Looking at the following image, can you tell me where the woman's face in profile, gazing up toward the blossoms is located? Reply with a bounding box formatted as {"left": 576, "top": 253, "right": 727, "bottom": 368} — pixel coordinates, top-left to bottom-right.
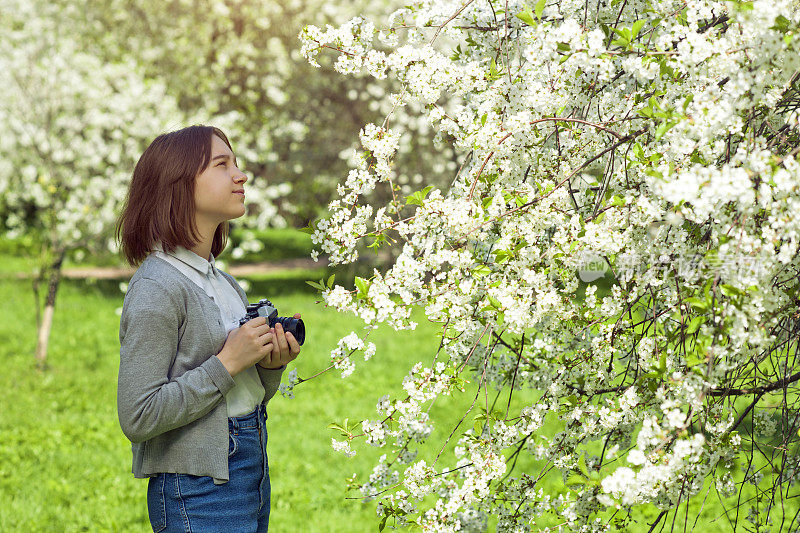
{"left": 194, "top": 135, "right": 247, "bottom": 228}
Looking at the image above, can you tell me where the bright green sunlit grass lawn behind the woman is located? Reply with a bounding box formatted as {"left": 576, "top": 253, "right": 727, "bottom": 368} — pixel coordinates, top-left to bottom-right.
{"left": 0, "top": 235, "right": 796, "bottom": 533}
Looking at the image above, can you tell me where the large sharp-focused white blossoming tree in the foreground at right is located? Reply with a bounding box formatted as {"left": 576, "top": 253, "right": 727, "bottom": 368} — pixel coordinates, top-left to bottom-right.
{"left": 296, "top": 0, "right": 800, "bottom": 531}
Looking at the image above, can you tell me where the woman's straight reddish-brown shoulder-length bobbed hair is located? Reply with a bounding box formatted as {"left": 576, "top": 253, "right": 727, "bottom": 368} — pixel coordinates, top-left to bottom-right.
{"left": 116, "top": 125, "right": 233, "bottom": 266}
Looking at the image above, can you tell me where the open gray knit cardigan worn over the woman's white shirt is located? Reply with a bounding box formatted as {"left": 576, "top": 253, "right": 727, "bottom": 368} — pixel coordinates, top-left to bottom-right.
{"left": 117, "top": 254, "right": 283, "bottom": 481}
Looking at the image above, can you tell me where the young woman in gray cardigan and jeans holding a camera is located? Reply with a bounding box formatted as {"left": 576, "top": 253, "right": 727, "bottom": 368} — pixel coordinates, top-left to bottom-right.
{"left": 117, "top": 126, "right": 300, "bottom": 532}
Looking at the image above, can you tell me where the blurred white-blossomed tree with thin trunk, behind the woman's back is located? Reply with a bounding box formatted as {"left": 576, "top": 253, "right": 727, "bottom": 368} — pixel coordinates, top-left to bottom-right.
{"left": 0, "top": 0, "right": 180, "bottom": 366}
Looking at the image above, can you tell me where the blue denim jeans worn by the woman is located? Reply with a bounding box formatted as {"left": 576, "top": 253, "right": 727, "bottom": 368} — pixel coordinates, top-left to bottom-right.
{"left": 147, "top": 404, "right": 270, "bottom": 533}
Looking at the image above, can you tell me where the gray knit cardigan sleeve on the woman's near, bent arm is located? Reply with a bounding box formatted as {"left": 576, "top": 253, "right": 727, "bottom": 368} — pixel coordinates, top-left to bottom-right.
{"left": 117, "top": 278, "right": 235, "bottom": 442}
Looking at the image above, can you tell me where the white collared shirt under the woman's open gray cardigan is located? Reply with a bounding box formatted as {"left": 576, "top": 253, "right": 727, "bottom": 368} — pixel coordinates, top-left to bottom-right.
{"left": 153, "top": 243, "right": 264, "bottom": 417}
